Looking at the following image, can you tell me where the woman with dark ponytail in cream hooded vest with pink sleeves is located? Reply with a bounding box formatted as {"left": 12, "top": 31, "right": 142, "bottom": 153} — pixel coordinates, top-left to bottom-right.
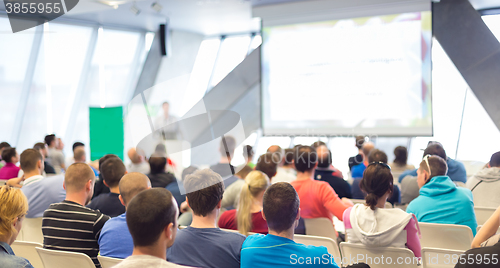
{"left": 343, "top": 161, "right": 421, "bottom": 257}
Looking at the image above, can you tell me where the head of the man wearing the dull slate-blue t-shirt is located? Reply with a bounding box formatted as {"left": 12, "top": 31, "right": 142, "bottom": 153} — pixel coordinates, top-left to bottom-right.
{"left": 184, "top": 168, "right": 224, "bottom": 217}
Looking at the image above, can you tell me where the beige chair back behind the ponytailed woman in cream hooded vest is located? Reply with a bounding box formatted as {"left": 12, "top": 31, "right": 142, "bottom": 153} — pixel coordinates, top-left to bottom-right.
{"left": 340, "top": 242, "right": 419, "bottom": 268}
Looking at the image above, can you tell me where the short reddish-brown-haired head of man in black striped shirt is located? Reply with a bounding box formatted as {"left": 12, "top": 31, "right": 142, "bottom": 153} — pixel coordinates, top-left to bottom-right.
{"left": 64, "top": 163, "right": 95, "bottom": 193}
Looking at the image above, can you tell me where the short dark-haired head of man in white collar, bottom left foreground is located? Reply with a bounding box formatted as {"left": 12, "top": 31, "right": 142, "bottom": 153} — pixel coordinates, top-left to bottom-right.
{"left": 127, "top": 188, "right": 177, "bottom": 247}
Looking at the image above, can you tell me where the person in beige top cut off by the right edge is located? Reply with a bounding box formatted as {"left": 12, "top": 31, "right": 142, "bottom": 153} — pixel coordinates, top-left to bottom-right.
{"left": 466, "top": 152, "right": 500, "bottom": 207}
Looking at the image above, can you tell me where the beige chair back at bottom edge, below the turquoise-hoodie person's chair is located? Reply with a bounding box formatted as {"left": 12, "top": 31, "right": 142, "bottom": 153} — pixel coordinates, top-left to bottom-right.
{"left": 422, "top": 248, "right": 464, "bottom": 268}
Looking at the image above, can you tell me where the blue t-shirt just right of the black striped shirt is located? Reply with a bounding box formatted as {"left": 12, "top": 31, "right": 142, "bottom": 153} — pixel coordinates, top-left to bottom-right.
{"left": 97, "top": 213, "right": 134, "bottom": 259}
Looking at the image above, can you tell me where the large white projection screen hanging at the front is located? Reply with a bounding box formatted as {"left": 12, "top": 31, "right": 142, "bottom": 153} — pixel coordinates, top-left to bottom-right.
{"left": 261, "top": 1, "right": 432, "bottom": 136}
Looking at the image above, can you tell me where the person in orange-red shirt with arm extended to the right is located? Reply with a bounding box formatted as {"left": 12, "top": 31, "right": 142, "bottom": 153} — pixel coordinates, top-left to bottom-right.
{"left": 291, "top": 146, "right": 353, "bottom": 226}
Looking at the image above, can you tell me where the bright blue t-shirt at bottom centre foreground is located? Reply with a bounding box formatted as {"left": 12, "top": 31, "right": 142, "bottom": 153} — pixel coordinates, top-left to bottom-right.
{"left": 241, "top": 234, "right": 338, "bottom": 268}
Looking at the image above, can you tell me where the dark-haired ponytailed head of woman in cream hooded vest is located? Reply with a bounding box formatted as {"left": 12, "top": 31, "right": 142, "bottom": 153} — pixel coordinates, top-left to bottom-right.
{"left": 359, "top": 162, "right": 394, "bottom": 210}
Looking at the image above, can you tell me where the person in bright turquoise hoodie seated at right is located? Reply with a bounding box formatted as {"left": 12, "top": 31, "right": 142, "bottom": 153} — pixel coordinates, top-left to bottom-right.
{"left": 406, "top": 155, "right": 477, "bottom": 235}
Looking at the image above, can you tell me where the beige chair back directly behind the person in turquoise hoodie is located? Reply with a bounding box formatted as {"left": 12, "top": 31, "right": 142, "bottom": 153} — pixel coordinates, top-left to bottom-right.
{"left": 418, "top": 222, "right": 474, "bottom": 251}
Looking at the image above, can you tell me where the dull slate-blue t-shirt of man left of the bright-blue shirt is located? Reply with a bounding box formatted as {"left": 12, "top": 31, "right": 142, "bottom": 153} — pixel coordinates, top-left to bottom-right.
{"left": 167, "top": 226, "right": 245, "bottom": 268}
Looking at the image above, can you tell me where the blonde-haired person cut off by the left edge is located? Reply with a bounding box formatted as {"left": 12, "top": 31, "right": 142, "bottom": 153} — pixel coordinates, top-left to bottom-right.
{"left": 0, "top": 185, "right": 33, "bottom": 268}
